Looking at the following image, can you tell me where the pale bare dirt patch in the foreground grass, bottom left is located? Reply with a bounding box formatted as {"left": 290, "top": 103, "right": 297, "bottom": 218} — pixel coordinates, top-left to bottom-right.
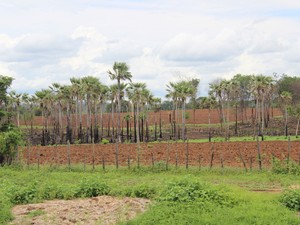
{"left": 10, "top": 196, "right": 150, "bottom": 225}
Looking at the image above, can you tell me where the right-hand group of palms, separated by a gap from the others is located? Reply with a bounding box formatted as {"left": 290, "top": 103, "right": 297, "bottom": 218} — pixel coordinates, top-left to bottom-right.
{"left": 201, "top": 74, "right": 300, "bottom": 139}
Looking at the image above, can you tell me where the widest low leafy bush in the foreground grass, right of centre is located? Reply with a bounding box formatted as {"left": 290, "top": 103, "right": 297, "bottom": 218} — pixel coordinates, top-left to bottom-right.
{"left": 159, "top": 179, "right": 237, "bottom": 206}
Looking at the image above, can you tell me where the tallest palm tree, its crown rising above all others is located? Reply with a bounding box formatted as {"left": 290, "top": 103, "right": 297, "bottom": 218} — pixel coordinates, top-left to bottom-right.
{"left": 107, "top": 62, "right": 132, "bottom": 168}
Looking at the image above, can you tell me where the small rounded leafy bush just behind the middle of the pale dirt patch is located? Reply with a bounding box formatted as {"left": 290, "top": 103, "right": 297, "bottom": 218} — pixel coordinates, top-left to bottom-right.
{"left": 74, "top": 179, "right": 110, "bottom": 198}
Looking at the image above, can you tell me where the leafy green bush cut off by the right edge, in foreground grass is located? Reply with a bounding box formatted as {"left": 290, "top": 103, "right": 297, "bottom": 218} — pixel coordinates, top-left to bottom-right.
{"left": 280, "top": 189, "right": 300, "bottom": 211}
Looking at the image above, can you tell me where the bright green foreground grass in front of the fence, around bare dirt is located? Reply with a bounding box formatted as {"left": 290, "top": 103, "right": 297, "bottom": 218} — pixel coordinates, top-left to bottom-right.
{"left": 0, "top": 165, "right": 300, "bottom": 224}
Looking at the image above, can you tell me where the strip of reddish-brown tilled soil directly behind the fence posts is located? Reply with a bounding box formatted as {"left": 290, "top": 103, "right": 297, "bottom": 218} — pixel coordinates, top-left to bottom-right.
{"left": 23, "top": 141, "right": 300, "bottom": 168}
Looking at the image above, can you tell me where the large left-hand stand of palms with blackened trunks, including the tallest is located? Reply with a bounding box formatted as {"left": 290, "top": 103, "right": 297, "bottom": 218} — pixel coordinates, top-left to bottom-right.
{"left": 9, "top": 62, "right": 173, "bottom": 145}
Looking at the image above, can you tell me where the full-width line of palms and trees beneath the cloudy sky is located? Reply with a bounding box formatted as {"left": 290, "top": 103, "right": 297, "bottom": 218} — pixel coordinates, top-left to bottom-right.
{"left": 4, "top": 62, "right": 300, "bottom": 147}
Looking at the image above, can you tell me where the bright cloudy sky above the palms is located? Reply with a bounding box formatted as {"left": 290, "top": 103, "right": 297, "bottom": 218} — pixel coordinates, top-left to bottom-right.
{"left": 0, "top": 0, "right": 300, "bottom": 98}
